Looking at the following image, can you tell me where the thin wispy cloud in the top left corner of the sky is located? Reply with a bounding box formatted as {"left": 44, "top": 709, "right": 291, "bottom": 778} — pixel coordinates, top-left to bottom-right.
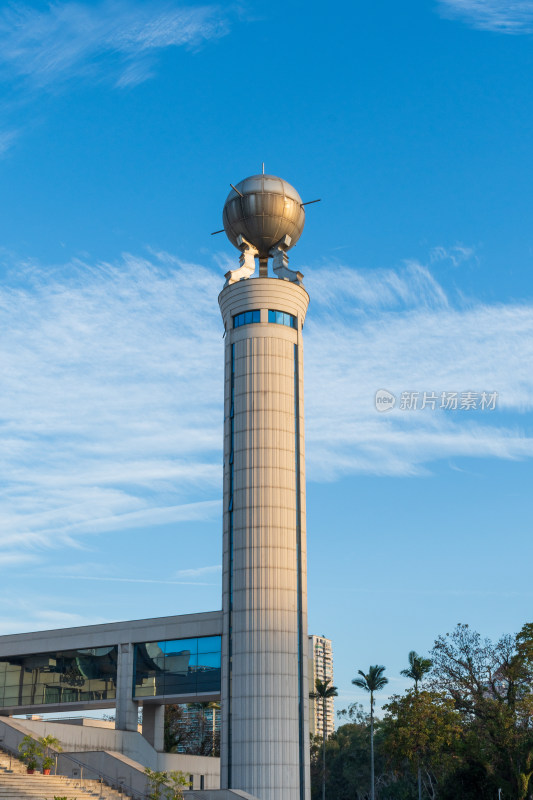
{"left": 0, "top": 0, "right": 228, "bottom": 87}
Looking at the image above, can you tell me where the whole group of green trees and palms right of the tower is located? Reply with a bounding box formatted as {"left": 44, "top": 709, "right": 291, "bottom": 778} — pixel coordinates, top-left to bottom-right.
{"left": 311, "top": 623, "right": 533, "bottom": 800}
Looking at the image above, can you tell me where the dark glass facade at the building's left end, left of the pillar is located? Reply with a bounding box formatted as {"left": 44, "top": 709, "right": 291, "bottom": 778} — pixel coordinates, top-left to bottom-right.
{"left": 0, "top": 645, "right": 118, "bottom": 708}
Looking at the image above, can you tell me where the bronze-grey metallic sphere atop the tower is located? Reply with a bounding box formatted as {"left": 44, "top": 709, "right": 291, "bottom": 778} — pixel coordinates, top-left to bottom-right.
{"left": 222, "top": 175, "right": 305, "bottom": 258}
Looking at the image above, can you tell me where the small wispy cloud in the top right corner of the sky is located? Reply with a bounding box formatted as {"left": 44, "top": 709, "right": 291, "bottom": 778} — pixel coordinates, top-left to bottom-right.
{"left": 439, "top": 0, "right": 533, "bottom": 34}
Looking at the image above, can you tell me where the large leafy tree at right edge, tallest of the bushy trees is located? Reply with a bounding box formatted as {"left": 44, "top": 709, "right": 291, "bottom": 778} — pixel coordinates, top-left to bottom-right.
{"left": 431, "top": 625, "right": 533, "bottom": 800}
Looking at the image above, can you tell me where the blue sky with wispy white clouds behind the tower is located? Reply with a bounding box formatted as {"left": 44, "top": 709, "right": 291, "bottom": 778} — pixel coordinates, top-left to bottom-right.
{"left": 0, "top": 0, "right": 533, "bottom": 707}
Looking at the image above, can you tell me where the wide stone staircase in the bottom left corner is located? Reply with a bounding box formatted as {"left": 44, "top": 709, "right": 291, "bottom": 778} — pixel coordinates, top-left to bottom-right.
{"left": 0, "top": 751, "right": 135, "bottom": 800}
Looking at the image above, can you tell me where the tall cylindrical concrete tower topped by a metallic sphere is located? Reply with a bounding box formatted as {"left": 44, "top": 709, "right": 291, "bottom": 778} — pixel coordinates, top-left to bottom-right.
{"left": 219, "top": 175, "right": 309, "bottom": 800}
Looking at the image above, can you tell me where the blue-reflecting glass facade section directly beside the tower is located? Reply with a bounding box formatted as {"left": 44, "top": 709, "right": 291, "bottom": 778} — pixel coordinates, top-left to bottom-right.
{"left": 133, "top": 636, "right": 221, "bottom": 698}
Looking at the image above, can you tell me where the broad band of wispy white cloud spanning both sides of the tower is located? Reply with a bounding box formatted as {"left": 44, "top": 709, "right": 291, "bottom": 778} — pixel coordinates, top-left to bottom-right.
{"left": 0, "top": 248, "right": 533, "bottom": 564}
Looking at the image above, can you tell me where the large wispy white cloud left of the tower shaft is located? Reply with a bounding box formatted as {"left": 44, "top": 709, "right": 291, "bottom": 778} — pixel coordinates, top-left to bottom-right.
{"left": 0, "top": 257, "right": 223, "bottom": 547}
